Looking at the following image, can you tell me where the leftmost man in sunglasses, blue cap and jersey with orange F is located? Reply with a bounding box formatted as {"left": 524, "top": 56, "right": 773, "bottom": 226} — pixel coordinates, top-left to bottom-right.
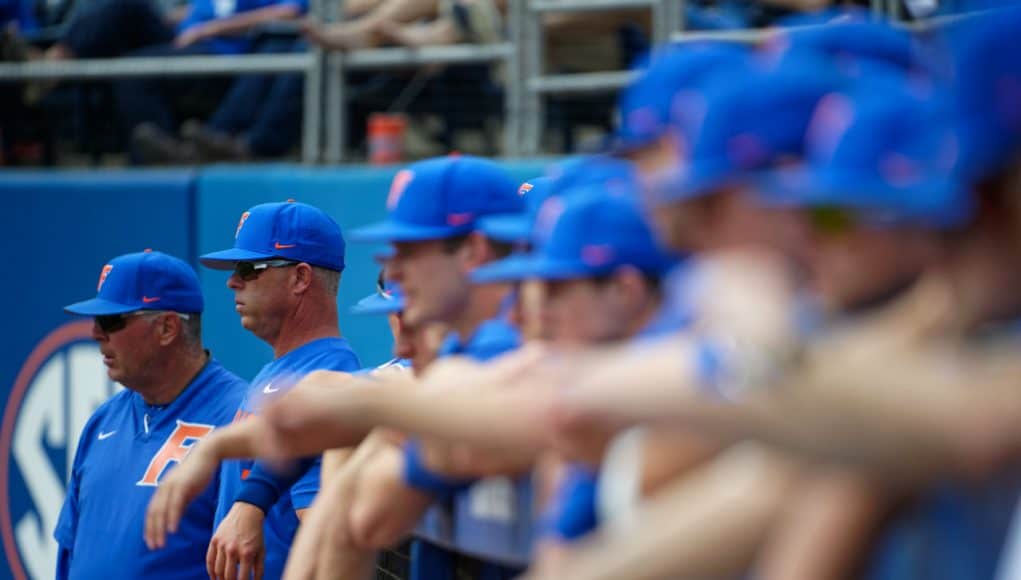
{"left": 54, "top": 250, "right": 246, "bottom": 579}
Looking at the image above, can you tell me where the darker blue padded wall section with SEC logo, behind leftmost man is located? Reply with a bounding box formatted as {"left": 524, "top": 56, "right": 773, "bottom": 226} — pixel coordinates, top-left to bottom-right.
{"left": 0, "top": 171, "right": 195, "bottom": 578}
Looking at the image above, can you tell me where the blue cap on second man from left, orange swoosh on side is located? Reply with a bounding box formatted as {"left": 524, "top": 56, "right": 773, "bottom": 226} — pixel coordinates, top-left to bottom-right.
{"left": 199, "top": 201, "right": 344, "bottom": 272}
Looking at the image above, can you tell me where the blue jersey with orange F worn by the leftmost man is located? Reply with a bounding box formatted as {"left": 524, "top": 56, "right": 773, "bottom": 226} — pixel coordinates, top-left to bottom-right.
{"left": 53, "top": 358, "right": 247, "bottom": 580}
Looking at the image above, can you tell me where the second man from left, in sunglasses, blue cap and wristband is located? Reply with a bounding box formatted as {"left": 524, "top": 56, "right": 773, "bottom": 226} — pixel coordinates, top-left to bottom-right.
{"left": 146, "top": 201, "right": 360, "bottom": 579}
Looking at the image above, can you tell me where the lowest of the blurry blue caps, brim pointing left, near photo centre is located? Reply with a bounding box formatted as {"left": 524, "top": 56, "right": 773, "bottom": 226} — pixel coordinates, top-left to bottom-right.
{"left": 472, "top": 186, "right": 677, "bottom": 284}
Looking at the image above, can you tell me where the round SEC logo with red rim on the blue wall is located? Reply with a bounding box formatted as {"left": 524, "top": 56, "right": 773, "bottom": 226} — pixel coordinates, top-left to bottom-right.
{"left": 0, "top": 321, "right": 123, "bottom": 579}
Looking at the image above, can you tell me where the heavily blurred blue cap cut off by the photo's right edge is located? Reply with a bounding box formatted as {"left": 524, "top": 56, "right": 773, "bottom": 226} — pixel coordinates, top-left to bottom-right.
{"left": 953, "top": 8, "right": 1021, "bottom": 180}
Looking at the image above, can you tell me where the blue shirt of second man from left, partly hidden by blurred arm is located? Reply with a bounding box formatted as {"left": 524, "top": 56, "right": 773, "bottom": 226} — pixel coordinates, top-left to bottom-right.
{"left": 216, "top": 338, "right": 360, "bottom": 579}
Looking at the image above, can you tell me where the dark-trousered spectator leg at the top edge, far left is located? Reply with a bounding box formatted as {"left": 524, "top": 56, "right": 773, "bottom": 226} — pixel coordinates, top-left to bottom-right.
{"left": 56, "top": 0, "right": 174, "bottom": 59}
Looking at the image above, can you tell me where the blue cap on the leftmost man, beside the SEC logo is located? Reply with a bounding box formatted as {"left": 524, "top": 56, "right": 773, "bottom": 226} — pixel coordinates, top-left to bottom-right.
{"left": 64, "top": 250, "right": 204, "bottom": 317}
